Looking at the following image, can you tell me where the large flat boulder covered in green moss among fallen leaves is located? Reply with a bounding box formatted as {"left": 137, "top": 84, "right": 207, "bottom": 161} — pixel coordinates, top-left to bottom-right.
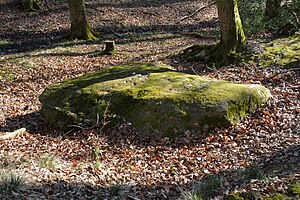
{"left": 40, "top": 63, "right": 270, "bottom": 137}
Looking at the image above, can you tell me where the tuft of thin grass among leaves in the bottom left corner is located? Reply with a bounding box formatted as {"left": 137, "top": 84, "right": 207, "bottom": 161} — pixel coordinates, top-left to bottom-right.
{"left": 0, "top": 170, "right": 24, "bottom": 194}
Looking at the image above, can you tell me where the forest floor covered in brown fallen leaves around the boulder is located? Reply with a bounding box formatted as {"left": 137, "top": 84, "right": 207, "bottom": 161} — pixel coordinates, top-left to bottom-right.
{"left": 0, "top": 0, "right": 300, "bottom": 199}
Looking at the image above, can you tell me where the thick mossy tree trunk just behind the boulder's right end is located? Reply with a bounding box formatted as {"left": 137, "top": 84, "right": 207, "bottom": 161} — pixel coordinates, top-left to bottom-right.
{"left": 208, "top": 0, "right": 245, "bottom": 65}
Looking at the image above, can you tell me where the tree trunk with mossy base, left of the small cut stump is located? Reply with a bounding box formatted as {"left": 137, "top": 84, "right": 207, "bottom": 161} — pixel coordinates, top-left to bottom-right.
{"left": 65, "top": 0, "right": 99, "bottom": 40}
